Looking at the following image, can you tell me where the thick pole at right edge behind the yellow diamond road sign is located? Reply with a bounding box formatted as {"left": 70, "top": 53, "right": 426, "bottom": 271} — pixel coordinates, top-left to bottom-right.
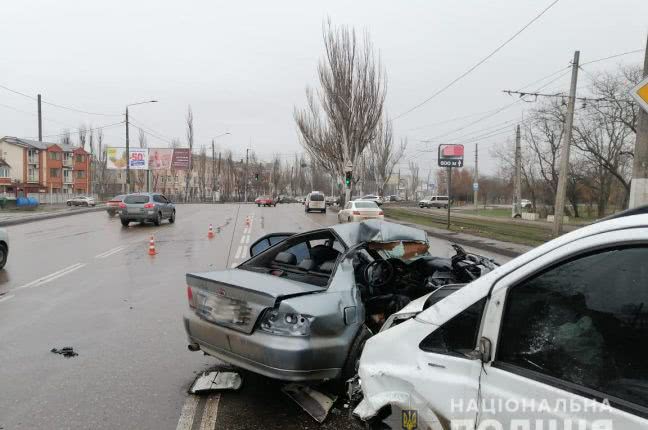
{"left": 629, "top": 34, "right": 648, "bottom": 208}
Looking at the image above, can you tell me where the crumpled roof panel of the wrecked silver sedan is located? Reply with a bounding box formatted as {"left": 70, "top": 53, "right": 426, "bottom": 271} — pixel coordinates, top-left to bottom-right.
{"left": 331, "top": 219, "right": 427, "bottom": 247}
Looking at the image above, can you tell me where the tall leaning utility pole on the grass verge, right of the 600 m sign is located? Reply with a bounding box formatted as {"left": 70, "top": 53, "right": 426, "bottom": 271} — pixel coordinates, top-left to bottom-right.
{"left": 553, "top": 51, "right": 580, "bottom": 236}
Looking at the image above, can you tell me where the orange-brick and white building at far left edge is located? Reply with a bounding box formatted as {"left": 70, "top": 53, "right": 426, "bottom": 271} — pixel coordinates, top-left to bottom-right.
{"left": 0, "top": 136, "right": 90, "bottom": 194}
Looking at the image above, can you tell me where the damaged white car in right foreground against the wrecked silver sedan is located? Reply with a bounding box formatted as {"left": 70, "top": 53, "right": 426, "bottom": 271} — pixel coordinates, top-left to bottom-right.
{"left": 354, "top": 206, "right": 648, "bottom": 430}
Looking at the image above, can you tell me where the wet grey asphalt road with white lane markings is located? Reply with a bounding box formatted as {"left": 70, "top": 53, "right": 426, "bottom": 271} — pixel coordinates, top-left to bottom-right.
{"left": 0, "top": 204, "right": 505, "bottom": 430}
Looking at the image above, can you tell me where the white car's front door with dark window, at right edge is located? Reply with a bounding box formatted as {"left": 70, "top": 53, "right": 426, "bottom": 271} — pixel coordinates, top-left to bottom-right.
{"left": 478, "top": 228, "right": 648, "bottom": 430}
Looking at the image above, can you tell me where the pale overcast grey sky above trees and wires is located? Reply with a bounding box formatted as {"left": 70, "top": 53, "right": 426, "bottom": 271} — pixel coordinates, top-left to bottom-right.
{"left": 0, "top": 0, "right": 648, "bottom": 173}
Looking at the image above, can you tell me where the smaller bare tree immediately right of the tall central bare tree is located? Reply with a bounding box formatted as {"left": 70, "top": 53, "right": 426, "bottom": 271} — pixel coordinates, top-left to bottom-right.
{"left": 369, "top": 121, "right": 404, "bottom": 195}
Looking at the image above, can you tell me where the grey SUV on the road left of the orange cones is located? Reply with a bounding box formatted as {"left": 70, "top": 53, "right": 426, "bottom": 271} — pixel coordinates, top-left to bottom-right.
{"left": 119, "top": 193, "right": 175, "bottom": 227}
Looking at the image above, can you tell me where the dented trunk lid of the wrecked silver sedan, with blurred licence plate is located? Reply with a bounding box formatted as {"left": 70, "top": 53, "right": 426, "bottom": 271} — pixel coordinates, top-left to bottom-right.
{"left": 187, "top": 269, "right": 324, "bottom": 334}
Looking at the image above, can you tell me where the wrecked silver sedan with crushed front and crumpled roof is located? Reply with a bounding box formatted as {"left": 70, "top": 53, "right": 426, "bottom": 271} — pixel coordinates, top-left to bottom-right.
{"left": 184, "top": 220, "right": 494, "bottom": 381}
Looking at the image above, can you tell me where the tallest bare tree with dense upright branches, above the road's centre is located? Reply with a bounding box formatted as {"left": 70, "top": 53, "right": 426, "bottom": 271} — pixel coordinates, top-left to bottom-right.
{"left": 294, "top": 20, "right": 385, "bottom": 200}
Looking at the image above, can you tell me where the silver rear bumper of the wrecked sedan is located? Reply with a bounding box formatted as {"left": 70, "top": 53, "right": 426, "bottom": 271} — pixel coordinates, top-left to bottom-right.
{"left": 183, "top": 313, "right": 345, "bottom": 381}
